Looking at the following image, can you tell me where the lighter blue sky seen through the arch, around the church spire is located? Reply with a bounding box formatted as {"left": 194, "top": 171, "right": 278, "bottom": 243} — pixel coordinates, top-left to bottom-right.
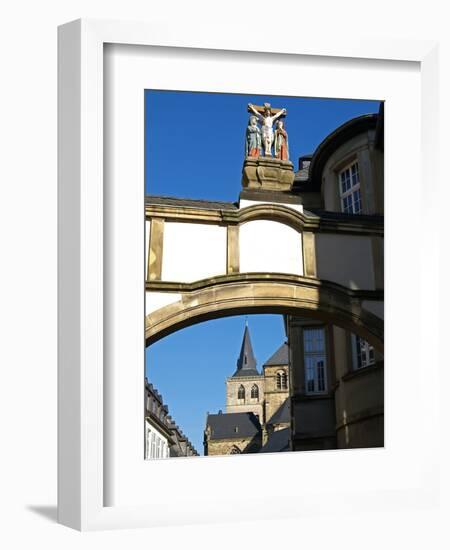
{"left": 147, "top": 315, "right": 286, "bottom": 454}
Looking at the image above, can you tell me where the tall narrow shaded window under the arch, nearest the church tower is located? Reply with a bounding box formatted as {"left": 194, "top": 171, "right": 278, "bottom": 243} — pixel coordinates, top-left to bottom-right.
{"left": 303, "top": 328, "right": 327, "bottom": 394}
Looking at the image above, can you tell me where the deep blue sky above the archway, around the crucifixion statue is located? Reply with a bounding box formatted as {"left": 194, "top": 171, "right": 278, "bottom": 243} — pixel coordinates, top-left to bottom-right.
{"left": 145, "top": 90, "right": 379, "bottom": 201}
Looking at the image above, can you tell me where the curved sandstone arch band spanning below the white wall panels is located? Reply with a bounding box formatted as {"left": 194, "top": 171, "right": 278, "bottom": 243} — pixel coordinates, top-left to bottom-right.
{"left": 145, "top": 273, "right": 384, "bottom": 352}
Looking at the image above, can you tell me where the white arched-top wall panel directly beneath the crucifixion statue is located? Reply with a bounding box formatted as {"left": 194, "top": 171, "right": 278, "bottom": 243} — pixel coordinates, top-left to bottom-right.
{"left": 239, "top": 220, "right": 303, "bottom": 275}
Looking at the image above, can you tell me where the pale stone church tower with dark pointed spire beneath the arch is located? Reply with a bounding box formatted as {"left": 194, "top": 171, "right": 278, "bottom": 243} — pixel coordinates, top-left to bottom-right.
{"left": 226, "top": 323, "right": 264, "bottom": 424}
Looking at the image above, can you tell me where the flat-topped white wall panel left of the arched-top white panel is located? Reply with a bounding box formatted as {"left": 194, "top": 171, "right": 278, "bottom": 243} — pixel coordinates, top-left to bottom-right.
{"left": 161, "top": 222, "right": 227, "bottom": 283}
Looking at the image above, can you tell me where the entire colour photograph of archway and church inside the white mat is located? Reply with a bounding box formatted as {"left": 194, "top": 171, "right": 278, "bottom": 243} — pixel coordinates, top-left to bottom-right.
{"left": 143, "top": 89, "right": 384, "bottom": 460}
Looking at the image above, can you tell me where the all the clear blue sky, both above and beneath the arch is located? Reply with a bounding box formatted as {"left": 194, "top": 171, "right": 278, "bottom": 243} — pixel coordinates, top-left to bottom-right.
{"left": 145, "top": 90, "right": 379, "bottom": 454}
